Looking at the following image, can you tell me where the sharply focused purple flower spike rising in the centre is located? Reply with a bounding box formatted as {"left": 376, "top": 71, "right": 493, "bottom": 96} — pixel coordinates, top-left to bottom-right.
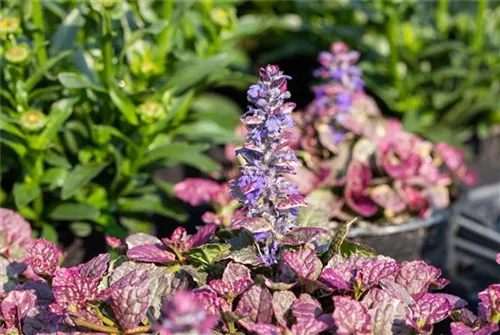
{"left": 231, "top": 65, "right": 305, "bottom": 264}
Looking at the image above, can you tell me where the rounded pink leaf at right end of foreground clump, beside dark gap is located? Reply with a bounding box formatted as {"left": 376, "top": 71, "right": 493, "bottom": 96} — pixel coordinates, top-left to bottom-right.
{"left": 411, "top": 293, "right": 453, "bottom": 330}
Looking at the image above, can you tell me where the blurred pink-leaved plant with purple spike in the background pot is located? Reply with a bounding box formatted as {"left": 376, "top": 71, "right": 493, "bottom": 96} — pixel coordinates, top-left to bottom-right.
{"left": 291, "top": 43, "right": 477, "bottom": 226}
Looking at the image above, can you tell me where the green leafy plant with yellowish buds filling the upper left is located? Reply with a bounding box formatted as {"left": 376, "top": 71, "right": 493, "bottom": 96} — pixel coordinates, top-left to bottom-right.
{"left": 0, "top": 1, "right": 252, "bottom": 240}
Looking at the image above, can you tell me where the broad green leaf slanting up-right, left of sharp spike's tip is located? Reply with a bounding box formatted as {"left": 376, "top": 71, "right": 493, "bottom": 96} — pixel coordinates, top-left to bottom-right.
{"left": 165, "top": 53, "right": 230, "bottom": 92}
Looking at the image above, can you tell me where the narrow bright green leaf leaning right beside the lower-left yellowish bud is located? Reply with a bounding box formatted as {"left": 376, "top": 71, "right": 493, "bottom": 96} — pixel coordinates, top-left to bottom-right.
{"left": 31, "top": 98, "right": 78, "bottom": 150}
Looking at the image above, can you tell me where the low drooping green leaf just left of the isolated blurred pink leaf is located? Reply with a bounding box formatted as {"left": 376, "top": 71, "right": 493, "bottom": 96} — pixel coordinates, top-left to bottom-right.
{"left": 118, "top": 194, "right": 187, "bottom": 221}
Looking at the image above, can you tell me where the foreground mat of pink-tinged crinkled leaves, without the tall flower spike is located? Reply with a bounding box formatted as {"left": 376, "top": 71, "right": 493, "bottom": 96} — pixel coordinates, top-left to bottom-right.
{"left": 0, "top": 207, "right": 500, "bottom": 335}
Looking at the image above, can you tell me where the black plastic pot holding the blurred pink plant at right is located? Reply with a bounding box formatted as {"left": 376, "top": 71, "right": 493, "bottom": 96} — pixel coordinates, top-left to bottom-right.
{"left": 348, "top": 209, "right": 452, "bottom": 264}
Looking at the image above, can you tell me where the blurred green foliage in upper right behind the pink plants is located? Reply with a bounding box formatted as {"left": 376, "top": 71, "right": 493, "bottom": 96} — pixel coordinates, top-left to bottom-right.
{"left": 239, "top": 0, "right": 500, "bottom": 144}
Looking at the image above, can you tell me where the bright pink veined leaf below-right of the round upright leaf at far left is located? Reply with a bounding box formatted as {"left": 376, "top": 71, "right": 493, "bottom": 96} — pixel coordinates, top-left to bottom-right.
{"left": 52, "top": 268, "right": 98, "bottom": 310}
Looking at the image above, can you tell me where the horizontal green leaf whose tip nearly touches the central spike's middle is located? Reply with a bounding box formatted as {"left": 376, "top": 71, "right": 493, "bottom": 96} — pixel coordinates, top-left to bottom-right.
{"left": 172, "top": 120, "right": 242, "bottom": 144}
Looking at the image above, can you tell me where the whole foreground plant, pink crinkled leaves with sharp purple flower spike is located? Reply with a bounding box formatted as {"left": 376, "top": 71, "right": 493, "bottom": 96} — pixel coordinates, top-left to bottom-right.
{"left": 0, "top": 65, "right": 500, "bottom": 335}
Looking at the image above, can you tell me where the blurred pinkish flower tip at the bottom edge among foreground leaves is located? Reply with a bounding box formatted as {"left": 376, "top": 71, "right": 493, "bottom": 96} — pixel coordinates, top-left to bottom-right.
{"left": 156, "top": 291, "right": 217, "bottom": 335}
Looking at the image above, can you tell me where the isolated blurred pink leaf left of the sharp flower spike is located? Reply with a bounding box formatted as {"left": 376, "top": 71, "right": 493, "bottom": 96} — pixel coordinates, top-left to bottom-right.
{"left": 174, "top": 178, "right": 221, "bottom": 206}
